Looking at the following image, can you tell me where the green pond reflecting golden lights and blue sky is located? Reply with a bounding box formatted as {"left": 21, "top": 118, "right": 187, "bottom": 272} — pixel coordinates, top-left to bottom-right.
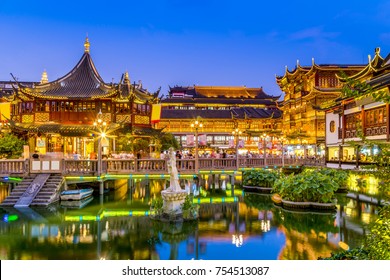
{"left": 0, "top": 176, "right": 378, "bottom": 260}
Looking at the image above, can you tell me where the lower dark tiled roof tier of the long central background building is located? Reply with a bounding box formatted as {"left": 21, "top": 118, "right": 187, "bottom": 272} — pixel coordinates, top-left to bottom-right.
{"left": 161, "top": 107, "right": 282, "bottom": 120}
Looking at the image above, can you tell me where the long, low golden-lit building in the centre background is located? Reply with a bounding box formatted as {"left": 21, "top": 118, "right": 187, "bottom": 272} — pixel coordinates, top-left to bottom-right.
{"left": 158, "top": 86, "right": 282, "bottom": 153}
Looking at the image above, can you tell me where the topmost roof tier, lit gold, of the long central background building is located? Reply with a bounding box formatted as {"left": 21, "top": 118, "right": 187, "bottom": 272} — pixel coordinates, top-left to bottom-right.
{"left": 164, "top": 86, "right": 280, "bottom": 103}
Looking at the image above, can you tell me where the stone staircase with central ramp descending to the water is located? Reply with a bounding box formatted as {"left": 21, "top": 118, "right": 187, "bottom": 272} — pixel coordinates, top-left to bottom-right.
{"left": 1, "top": 174, "right": 65, "bottom": 207}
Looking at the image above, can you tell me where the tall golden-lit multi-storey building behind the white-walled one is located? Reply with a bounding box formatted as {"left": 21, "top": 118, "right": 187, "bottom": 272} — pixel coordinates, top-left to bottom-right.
{"left": 276, "top": 59, "right": 364, "bottom": 157}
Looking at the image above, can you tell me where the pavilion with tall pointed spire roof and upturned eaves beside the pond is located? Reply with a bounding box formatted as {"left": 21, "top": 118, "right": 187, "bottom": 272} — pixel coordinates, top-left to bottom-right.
{"left": 5, "top": 38, "right": 158, "bottom": 158}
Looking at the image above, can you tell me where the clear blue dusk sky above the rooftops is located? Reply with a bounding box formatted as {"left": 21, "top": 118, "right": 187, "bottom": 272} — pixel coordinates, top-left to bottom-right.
{"left": 0, "top": 0, "right": 390, "bottom": 98}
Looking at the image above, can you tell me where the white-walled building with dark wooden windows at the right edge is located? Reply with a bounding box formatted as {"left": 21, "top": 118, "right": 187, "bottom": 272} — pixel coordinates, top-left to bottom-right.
{"left": 321, "top": 48, "right": 390, "bottom": 168}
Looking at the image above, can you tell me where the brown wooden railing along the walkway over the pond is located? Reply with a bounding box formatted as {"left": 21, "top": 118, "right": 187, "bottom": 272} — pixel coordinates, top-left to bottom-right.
{"left": 0, "top": 157, "right": 325, "bottom": 177}
